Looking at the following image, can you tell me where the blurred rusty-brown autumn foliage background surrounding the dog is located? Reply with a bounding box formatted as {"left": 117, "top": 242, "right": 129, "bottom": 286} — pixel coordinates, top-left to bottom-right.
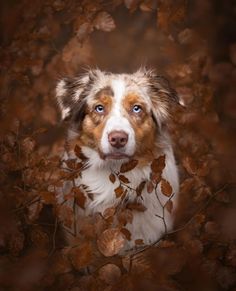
{"left": 0, "top": 0, "right": 236, "bottom": 291}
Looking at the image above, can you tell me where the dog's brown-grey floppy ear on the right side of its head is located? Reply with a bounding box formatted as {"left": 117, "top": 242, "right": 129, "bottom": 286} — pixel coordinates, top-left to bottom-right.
{"left": 136, "top": 68, "right": 181, "bottom": 125}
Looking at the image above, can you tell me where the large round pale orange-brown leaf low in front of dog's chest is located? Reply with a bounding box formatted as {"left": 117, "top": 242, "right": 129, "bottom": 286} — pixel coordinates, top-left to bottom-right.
{"left": 97, "top": 228, "right": 125, "bottom": 257}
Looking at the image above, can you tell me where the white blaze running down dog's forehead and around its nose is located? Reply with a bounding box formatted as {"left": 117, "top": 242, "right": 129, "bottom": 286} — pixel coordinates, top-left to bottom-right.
{"left": 101, "top": 76, "right": 135, "bottom": 155}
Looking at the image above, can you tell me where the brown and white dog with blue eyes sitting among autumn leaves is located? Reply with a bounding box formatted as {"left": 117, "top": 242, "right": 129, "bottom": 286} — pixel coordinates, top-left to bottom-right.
{"left": 56, "top": 69, "right": 179, "bottom": 248}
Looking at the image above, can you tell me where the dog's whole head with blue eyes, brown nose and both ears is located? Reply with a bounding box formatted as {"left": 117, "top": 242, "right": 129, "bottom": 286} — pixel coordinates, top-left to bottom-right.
{"left": 56, "top": 69, "right": 178, "bottom": 161}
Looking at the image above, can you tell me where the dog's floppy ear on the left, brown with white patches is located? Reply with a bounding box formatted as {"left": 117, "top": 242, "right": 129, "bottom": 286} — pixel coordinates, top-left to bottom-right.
{"left": 56, "top": 73, "right": 90, "bottom": 120}
